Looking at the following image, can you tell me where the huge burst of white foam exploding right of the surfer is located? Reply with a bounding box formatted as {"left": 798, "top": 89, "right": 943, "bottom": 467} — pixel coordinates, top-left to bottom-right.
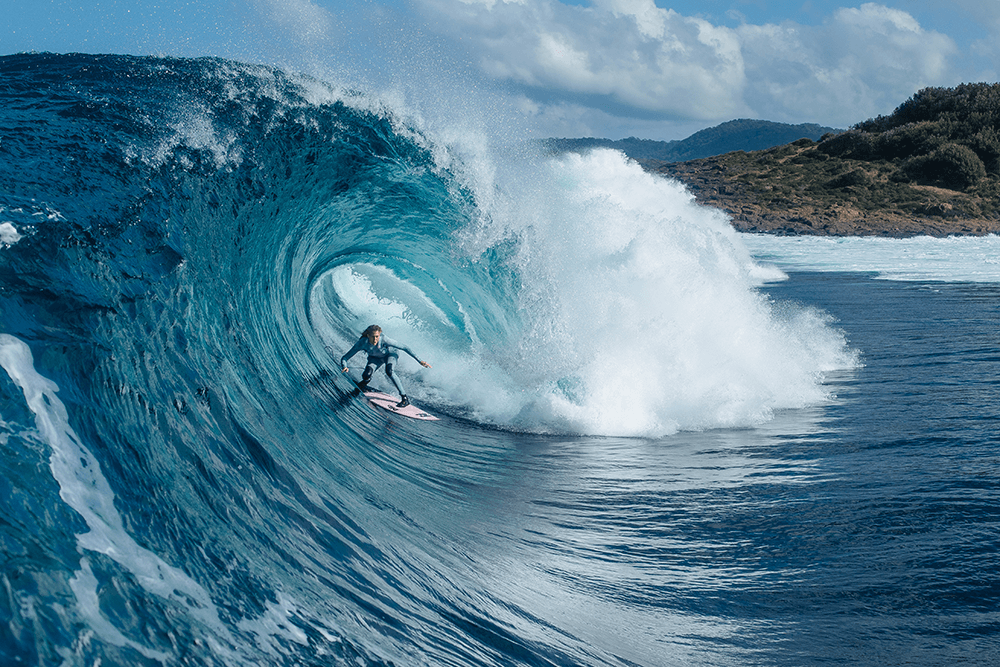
{"left": 404, "top": 151, "right": 856, "bottom": 436}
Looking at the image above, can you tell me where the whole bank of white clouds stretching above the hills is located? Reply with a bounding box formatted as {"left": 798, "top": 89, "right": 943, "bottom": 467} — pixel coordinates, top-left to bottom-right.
{"left": 408, "top": 0, "right": 957, "bottom": 136}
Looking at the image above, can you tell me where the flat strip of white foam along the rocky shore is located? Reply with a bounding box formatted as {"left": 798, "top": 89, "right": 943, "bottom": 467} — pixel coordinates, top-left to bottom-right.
{"left": 740, "top": 234, "right": 1000, "bottom": 283}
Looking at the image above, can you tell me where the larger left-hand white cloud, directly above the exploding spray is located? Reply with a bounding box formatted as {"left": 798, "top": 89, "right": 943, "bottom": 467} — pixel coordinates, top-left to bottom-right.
{"left": 414, "top": 0, "right": 746, "bottom": 118}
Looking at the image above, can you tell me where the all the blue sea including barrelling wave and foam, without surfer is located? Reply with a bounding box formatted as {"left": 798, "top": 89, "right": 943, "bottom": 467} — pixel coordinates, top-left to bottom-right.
{"left": 0, "top": 54, "right": 1000, "bottom": 666}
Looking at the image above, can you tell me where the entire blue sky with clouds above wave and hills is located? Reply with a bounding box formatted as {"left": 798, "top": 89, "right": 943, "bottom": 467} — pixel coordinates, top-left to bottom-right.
{"left": 0, "top": 0, "right": 1000, "bottom": 140}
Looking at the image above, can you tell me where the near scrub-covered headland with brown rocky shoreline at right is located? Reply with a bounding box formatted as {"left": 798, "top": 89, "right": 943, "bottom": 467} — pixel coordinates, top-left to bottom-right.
{"left": 639, "top": 83, "right": 1000, "bottom": 237}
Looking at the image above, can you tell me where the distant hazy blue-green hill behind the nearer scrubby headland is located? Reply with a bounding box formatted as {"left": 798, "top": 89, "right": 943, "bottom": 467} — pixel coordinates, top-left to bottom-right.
{"left": 544, "top": 118, "right": 840, "bottom": 162}
